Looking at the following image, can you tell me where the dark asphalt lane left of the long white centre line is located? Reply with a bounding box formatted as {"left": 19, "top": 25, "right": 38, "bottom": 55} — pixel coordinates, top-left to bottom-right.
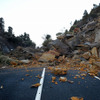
{"left": 0, "top": 69, "right": 42, "bottom": 100}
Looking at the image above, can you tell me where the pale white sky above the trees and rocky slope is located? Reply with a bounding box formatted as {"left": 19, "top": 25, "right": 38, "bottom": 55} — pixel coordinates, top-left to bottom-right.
{"left": 0, "top": 0, "right": 100, "bottom": 46}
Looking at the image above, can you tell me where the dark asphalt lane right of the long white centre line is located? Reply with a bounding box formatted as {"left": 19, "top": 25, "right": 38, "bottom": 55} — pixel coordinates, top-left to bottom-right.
{"left": 42, "top": 71, "right": 100, "bottom": 100}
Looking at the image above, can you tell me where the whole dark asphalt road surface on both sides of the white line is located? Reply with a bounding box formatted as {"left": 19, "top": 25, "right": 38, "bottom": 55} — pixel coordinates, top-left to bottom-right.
{"left": 0, "top": 68, "right": 100, "bottom": 100}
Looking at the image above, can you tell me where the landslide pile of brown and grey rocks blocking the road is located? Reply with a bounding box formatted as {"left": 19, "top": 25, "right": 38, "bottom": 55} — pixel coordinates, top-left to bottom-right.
{"left": 0, "top": 4, "right": 100, "bottom": 76}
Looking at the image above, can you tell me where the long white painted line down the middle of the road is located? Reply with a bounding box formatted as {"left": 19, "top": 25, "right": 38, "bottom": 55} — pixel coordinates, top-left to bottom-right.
{"left": 35, "top": 68, "right": 45, "bottom": 100}
